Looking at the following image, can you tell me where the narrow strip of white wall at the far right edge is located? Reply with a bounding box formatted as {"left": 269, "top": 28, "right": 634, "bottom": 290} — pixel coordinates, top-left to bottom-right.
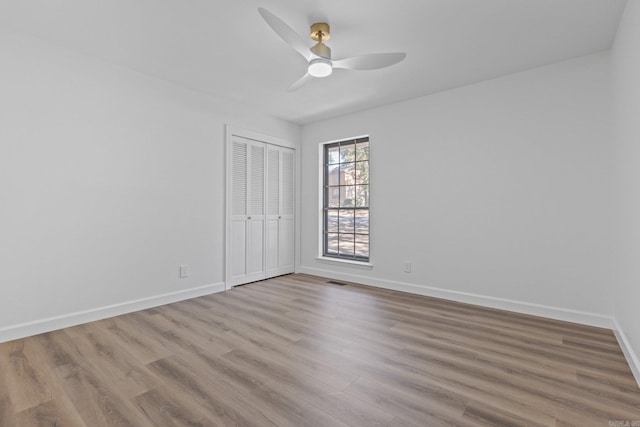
{"left": 612, "top": 1, "right": 640, "bottom": 383}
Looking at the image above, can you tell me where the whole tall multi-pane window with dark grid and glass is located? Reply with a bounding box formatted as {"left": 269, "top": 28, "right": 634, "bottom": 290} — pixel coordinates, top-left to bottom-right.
{"left": 323, "top": 137, "right": 369, "bottom": 262}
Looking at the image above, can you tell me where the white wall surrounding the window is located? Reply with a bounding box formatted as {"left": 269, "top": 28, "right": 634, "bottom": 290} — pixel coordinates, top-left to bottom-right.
{"left": 301, "top": 53, "right": 613, "bottom": 325}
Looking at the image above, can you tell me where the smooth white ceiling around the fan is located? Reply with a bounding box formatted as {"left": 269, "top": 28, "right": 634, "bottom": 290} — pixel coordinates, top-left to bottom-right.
{"left": 0, "top": 0, "right": 625, "bottom": 124}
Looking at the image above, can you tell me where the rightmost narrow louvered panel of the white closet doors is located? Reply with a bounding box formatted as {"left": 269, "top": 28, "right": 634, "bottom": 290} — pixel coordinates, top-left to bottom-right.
{"left": 278, "top": 148, "right": 295, "bottom": 274}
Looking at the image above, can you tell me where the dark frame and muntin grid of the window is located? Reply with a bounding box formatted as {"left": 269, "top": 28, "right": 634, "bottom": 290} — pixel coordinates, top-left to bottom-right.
{"left": 322, "top": 136, "right": 371, "bottom": 263}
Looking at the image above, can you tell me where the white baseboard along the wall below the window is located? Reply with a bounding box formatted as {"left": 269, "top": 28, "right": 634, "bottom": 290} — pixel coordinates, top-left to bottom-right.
{"left": 299, "top": 266, "right": 614, "bottom": 329}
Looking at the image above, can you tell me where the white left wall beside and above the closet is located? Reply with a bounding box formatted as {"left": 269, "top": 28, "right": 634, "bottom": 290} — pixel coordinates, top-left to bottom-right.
{"left": 0, "top": 30, "right": 300, "bottom": 341}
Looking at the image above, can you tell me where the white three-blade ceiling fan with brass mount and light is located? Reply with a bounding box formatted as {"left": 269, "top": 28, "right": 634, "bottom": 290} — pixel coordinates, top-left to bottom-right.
{"left": 258, "top": 7, "right": 407, "bottom": 91}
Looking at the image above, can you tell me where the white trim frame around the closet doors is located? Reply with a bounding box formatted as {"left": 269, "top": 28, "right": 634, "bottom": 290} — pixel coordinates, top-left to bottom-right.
{"left": 224, "top": 124, "right": 300, "bottom": 290}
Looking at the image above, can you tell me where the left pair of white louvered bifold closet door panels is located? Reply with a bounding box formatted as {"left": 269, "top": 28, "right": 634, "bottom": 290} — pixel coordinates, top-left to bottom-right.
{"left": 227, "top": 137, "right": 265, "bottom": 286}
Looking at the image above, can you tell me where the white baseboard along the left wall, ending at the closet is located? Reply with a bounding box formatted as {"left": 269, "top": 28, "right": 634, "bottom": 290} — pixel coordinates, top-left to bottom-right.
{"left": 0, "top": 283, "right": 225, "bottom": 343}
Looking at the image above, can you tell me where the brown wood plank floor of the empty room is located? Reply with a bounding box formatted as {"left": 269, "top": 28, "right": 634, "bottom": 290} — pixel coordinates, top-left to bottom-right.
{"left": 0, "top": 275, "right": 640, "bottom": 427}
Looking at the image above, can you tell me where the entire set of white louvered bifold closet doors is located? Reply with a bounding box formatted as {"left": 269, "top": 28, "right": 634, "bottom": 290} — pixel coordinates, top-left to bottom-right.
{"left": 226, "top": 135, "right": 295, "bottom": 286}
